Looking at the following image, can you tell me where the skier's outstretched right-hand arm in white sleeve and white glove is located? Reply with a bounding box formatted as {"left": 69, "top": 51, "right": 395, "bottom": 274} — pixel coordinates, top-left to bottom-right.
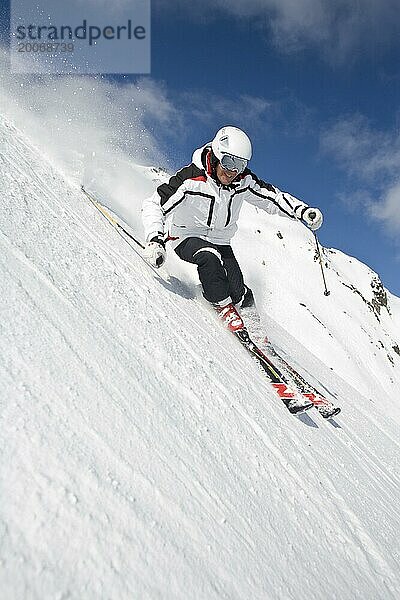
{"left": 246, "top": 171, "right": 322, "bottom": 229}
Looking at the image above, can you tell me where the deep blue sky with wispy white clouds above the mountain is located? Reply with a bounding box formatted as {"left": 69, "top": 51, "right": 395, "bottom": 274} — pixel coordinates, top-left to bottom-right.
{"left": 0, "top": 0, "right": 400, "bottom": 296}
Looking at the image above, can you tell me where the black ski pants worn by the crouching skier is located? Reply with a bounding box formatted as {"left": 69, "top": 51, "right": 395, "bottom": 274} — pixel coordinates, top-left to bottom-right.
{"left": 175, "top": 237, "right": 246, "bottom": 304}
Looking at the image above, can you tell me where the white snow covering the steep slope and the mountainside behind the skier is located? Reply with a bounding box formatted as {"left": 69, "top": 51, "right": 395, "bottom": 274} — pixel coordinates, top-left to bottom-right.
{"left": 0, "top": 119, "right": 400, "bottom": 600}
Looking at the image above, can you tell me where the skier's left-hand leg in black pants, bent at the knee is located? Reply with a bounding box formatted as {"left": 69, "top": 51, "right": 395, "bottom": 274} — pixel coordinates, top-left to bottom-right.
{"left": 175, "top": 237, "right": 231, "bottom": 304}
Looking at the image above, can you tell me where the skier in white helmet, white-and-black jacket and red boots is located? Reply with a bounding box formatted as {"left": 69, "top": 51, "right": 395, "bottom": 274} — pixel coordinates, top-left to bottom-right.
{"left": 142, "top": 126, "right": 323, "bottom": 335}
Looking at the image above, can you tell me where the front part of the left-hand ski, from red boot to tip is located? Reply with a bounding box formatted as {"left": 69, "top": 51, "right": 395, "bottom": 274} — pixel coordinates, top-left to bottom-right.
{"left": 234, "top": 329, "right": 314, "bottom": 415}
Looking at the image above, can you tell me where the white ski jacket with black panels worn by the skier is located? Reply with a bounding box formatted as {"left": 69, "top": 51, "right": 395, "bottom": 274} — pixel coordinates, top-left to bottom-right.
{"left": 142, "top": 145, "right": 308, "bottom": 245}
